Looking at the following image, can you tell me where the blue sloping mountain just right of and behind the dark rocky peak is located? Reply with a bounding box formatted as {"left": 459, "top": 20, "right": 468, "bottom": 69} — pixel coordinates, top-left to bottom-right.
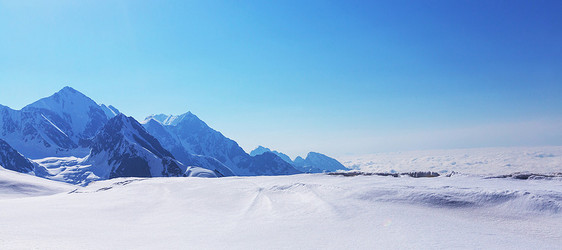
{"left": 143, "top": 112, "right": 300, "bottom": 175}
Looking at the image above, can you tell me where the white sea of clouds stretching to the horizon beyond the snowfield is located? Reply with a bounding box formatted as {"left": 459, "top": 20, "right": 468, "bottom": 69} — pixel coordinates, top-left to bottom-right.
{"left": 339, "top": 146, "right": 562, "bottom": 175}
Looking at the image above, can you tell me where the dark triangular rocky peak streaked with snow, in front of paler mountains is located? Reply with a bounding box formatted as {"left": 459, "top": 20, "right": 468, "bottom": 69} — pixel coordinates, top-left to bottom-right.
{"left": 83, "top": 114, "right": 216, "bottom": 179}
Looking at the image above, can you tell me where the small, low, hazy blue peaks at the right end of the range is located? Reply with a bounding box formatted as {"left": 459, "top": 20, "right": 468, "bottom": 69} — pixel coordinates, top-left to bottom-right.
{"left": 250, "top": 146, "right": 349, "bottom": 173}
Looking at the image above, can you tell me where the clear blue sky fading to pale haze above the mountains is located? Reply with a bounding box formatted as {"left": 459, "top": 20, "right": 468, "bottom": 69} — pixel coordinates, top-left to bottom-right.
{"left": 0, "top": 0, "right": 562, "bottom": 157}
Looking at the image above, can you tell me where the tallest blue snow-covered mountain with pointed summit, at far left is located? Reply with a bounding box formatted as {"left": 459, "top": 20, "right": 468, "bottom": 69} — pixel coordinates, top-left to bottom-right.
{"left": 0, "top": 87, "right": 112, "bottom": 159}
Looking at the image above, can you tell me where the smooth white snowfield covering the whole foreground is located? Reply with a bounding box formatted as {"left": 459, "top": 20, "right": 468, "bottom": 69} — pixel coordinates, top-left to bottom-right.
{"left": 0, "top": 169, "right": 562, "bottom": 249}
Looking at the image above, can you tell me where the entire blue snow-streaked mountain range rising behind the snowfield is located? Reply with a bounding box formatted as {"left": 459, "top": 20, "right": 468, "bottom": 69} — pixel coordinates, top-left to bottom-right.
{"left": 0, "top": 87, "right": 343, "bottom": 184}
